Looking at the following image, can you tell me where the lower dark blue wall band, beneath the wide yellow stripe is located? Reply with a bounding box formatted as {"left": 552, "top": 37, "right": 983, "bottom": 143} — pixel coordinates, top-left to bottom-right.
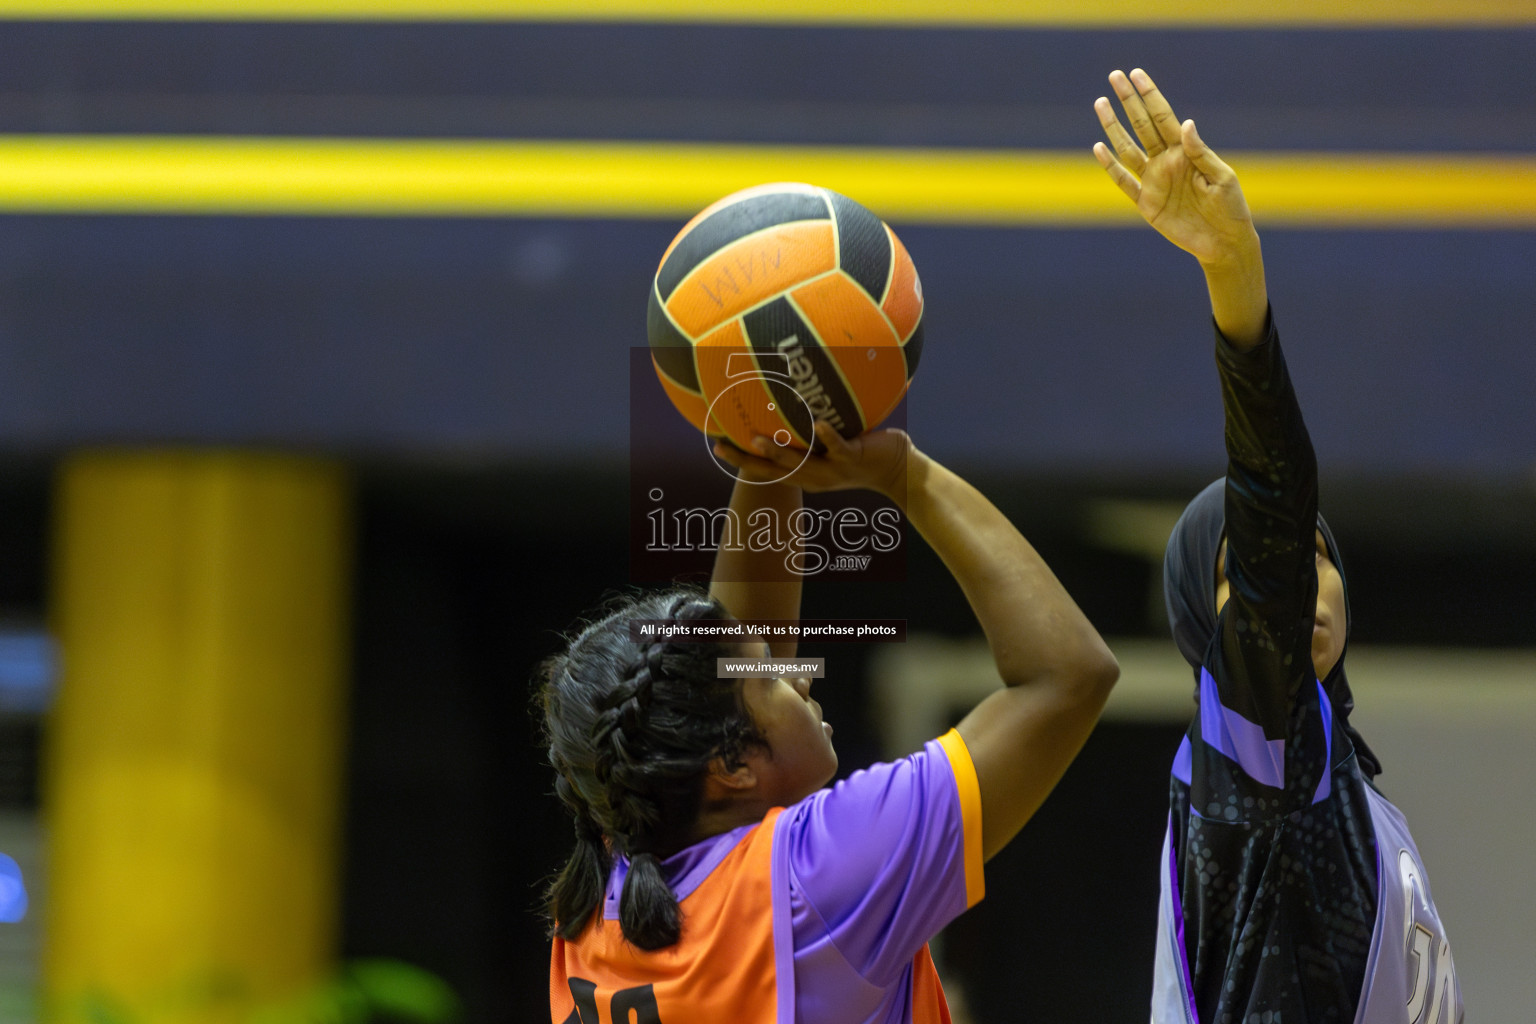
{"left": 0, "top": 216, "right": 1536, "bottom": 476}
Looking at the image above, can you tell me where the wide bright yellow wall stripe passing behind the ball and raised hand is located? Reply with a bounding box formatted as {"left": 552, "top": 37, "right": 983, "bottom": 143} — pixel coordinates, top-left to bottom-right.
{"left": 0, "top": 135, "right": 1536, "bottom": 229}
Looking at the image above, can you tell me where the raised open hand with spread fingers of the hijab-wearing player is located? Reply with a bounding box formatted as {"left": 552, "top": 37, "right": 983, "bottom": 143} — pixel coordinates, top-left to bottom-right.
{"left": 1094, "top": 68, "right": 1258, "bottom": 264}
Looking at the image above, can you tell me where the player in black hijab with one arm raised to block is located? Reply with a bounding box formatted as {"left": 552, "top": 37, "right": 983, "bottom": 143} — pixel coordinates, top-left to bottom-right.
{"left": 1094, "top": 69, "right": 1462, "bottom": 1024}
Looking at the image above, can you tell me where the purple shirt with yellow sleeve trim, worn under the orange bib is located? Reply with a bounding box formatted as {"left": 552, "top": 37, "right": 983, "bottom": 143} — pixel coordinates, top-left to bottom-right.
{"left": 604, "top": 732, "right": 982, "bottom": 1024}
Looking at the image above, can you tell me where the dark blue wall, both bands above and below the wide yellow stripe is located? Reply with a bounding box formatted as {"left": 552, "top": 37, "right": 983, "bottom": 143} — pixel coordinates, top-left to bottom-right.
{"left": 0, "top": 23, "right": 1536, "bottom": 479}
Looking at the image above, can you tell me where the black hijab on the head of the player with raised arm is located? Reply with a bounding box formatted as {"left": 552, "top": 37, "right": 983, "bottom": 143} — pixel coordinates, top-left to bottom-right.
{"left": 1163, "top": 477, "right": 1381, "bottom": 778}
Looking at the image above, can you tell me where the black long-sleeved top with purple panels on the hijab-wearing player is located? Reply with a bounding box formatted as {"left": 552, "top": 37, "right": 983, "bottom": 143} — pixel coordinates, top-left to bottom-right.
{"left": 1170, "top": 310, "right": 1376, "bottom": 1024}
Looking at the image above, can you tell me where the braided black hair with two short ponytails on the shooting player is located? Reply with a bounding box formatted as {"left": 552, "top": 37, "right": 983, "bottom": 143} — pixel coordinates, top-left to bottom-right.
{"left": 539, "top": 588, "right": 762, "bottom": 949}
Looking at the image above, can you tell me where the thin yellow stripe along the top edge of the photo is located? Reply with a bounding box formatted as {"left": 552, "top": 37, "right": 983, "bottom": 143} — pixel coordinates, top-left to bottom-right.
{"left": 0, "top": 0, "right": 1536, "bottom": 28}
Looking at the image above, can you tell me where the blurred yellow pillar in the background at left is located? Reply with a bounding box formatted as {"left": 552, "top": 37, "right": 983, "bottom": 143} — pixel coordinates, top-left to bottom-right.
{"left": 43, "top": 451, "right": 350, "bottom": 1024}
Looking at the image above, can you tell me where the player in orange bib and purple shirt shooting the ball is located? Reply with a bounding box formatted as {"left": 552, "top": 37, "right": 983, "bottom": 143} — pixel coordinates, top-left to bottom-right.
{"left": 541, "top": 422, "right": 1118, "bottom": 1024}
